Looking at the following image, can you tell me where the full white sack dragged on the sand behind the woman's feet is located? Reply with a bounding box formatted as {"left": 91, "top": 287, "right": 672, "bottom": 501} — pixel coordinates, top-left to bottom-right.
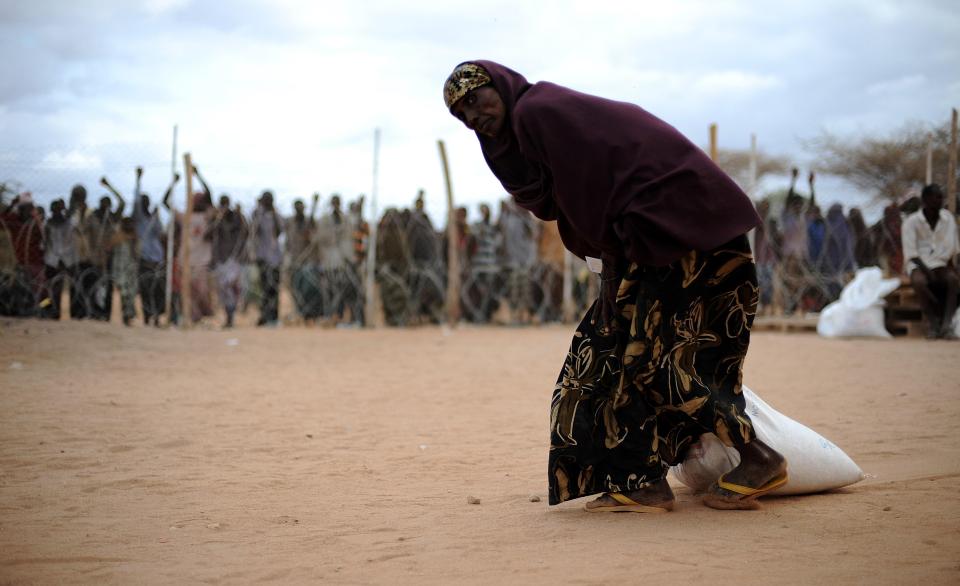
{"left": 671, "top": 386, "right": 864, "bottom": 495}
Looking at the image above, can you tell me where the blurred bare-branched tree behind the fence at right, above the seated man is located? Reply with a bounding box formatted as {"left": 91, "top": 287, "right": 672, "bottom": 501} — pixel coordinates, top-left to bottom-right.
{"left": 806, "top": 122, "right": 957, "bottom": 201}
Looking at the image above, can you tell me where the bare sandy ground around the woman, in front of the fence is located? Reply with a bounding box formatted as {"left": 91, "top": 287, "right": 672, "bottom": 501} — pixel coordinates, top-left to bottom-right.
{"left": 0, "top": 320, "right": 960, "bottom": 585}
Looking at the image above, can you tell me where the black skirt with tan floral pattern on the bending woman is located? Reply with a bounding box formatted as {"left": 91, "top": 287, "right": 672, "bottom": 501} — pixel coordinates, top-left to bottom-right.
{"left": 549, "top": 236, "right": 758, "bottom": 505}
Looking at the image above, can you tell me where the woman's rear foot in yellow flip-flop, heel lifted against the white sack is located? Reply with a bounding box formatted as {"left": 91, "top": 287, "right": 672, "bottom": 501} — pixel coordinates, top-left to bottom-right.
{"left": 703, "top": 439, "right": 787, "bottom": 509}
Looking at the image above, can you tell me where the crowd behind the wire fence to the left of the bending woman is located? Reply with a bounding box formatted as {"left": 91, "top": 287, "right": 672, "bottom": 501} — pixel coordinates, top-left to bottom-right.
{"left": 0, "top": 167, "right": 589, "bottom": 327}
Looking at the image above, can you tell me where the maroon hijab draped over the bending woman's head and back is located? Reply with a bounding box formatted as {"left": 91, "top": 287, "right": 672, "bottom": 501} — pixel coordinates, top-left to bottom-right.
{"left": 471, "top": 60, "right": 760, "bottom": 266}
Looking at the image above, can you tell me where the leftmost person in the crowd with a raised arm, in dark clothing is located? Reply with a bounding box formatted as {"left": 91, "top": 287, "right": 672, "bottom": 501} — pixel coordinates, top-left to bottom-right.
{"left": 81, "top": 177, "right": 126, "bottom": 321}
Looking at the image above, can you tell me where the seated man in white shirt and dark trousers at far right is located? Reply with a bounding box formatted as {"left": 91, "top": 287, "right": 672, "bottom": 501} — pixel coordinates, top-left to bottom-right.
{"left": 902, "top": 184, "right": 960, "bottom": 339}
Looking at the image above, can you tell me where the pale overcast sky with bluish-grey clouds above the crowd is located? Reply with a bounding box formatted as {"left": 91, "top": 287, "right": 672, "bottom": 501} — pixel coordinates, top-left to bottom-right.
{"left": 0, "top": 0, "right": 960, "bottom": 217}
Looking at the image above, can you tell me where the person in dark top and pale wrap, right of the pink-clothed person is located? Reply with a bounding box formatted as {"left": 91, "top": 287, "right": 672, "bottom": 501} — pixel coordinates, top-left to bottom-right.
{"left": 211, "top": 194, "right": 248, "bottom": 328}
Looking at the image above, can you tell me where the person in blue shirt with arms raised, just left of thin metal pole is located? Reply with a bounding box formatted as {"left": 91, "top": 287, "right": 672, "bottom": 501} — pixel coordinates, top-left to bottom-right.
{"left": 133, "top": 167, "right": 180, "bottom": 327}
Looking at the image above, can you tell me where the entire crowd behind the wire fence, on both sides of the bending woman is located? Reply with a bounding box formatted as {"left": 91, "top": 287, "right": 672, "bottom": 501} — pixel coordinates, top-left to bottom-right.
{"left": 0, "top": 163, "right": 956, "bottom": 334}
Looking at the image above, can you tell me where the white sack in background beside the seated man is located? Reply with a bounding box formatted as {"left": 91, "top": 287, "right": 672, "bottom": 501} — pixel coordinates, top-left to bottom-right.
{"left": 817, "top": 267, "right": 900, "bottom": 338}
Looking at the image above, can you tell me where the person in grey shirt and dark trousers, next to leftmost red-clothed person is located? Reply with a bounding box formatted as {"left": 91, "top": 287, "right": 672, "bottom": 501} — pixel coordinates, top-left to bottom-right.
{"left": 40, "top": 199, "right": 79, "bottom": 319}
